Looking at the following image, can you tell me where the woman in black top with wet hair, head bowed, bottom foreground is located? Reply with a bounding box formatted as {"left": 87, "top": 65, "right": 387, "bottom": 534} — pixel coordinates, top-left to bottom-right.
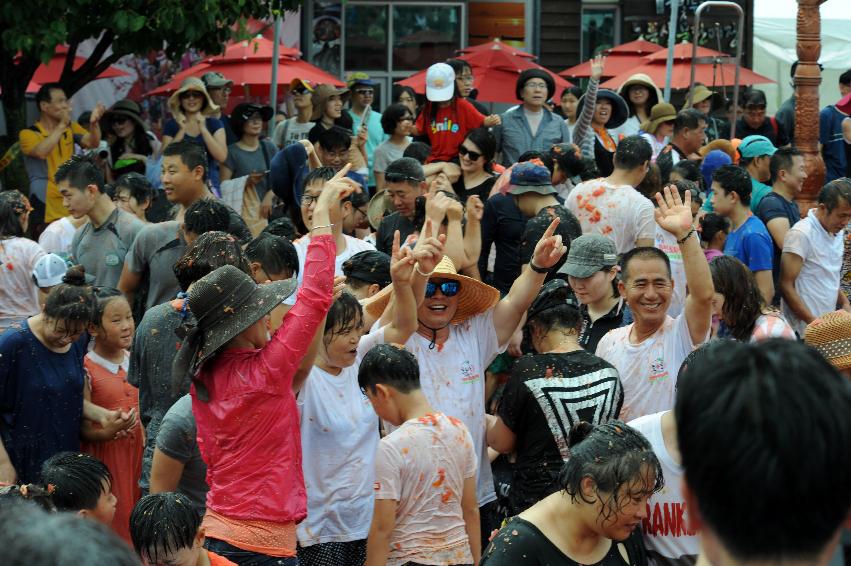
{"left": 479, "top": 421, "right": 664, "bottom": 566}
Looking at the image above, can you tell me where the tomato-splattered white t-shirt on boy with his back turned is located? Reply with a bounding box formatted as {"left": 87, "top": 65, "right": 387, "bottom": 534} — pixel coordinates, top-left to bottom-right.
{"left": 375, "top": 413, "right": 476, "bottom": 566}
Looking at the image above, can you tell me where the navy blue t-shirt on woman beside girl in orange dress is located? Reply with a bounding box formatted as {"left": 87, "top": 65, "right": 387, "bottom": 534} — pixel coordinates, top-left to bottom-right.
{"left": 0, "top": 320, "right": 87, "bottom": 483}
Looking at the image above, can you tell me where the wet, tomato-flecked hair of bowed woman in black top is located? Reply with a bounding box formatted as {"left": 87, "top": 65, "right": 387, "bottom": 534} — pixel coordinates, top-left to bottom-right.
{"left": 558, "top": 420, "right": 665, "bottom": 524}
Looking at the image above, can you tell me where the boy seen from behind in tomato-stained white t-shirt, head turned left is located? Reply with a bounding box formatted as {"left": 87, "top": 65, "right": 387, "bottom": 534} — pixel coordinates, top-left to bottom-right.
{"left": 358, "top": 344, "right": 481, "bottom": 566}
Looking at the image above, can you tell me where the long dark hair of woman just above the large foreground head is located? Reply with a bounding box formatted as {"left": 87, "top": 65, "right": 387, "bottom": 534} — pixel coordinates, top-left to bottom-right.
{"left": 709, "top": 255, "right": 765, "bottom": 342}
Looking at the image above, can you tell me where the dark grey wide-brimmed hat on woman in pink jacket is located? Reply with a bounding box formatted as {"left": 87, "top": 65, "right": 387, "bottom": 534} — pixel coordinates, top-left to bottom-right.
{"left": 172, "top": 265, "right": 298, "bottom": 392}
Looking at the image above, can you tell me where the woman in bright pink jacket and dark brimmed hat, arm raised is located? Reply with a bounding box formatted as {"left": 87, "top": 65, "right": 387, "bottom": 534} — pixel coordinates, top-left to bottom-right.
{"left": 173, "top": 166, "right": 359, "bottom": 564}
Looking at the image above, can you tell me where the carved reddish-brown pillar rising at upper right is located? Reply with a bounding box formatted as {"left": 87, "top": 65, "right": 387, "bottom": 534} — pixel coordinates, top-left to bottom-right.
{"left": 795, "top": 0, "right": 825, "bottom": 212}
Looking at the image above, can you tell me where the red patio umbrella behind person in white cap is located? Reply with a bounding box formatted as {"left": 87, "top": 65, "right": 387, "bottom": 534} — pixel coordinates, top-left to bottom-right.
{"left": 398, "top": 49, "right": 572, "bottom": 103}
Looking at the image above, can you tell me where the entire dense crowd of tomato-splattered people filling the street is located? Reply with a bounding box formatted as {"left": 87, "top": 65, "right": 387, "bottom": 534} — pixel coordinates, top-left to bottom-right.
{"left": 0, "top": 51, "right": 851, "bottom": 566}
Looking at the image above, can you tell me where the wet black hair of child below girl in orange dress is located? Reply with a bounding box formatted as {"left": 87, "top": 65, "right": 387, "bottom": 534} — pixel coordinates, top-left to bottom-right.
{"left": 41, "top": 452, "right": 112, "bottom": 511}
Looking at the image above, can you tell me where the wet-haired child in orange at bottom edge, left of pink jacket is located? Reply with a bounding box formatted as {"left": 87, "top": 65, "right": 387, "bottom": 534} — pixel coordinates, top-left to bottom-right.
{"left": 130, "top": 492, "right": 235, "bottom": 566}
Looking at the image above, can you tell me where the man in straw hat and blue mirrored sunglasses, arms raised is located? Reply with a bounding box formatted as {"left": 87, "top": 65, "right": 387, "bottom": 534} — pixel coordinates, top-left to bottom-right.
{"left": 366, "top": 212, "right": 566, "bottom": 545}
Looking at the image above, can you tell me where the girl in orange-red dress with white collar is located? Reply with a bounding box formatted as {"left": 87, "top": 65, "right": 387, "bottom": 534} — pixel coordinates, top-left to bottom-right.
{"left": 82, "top": 287, "right": 144, "bottom": 543}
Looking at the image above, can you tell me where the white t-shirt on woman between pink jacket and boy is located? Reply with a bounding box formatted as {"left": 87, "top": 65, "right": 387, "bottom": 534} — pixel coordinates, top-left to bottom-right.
{"left": 297, "top": 329, "right": 384, "bottom": 546}
